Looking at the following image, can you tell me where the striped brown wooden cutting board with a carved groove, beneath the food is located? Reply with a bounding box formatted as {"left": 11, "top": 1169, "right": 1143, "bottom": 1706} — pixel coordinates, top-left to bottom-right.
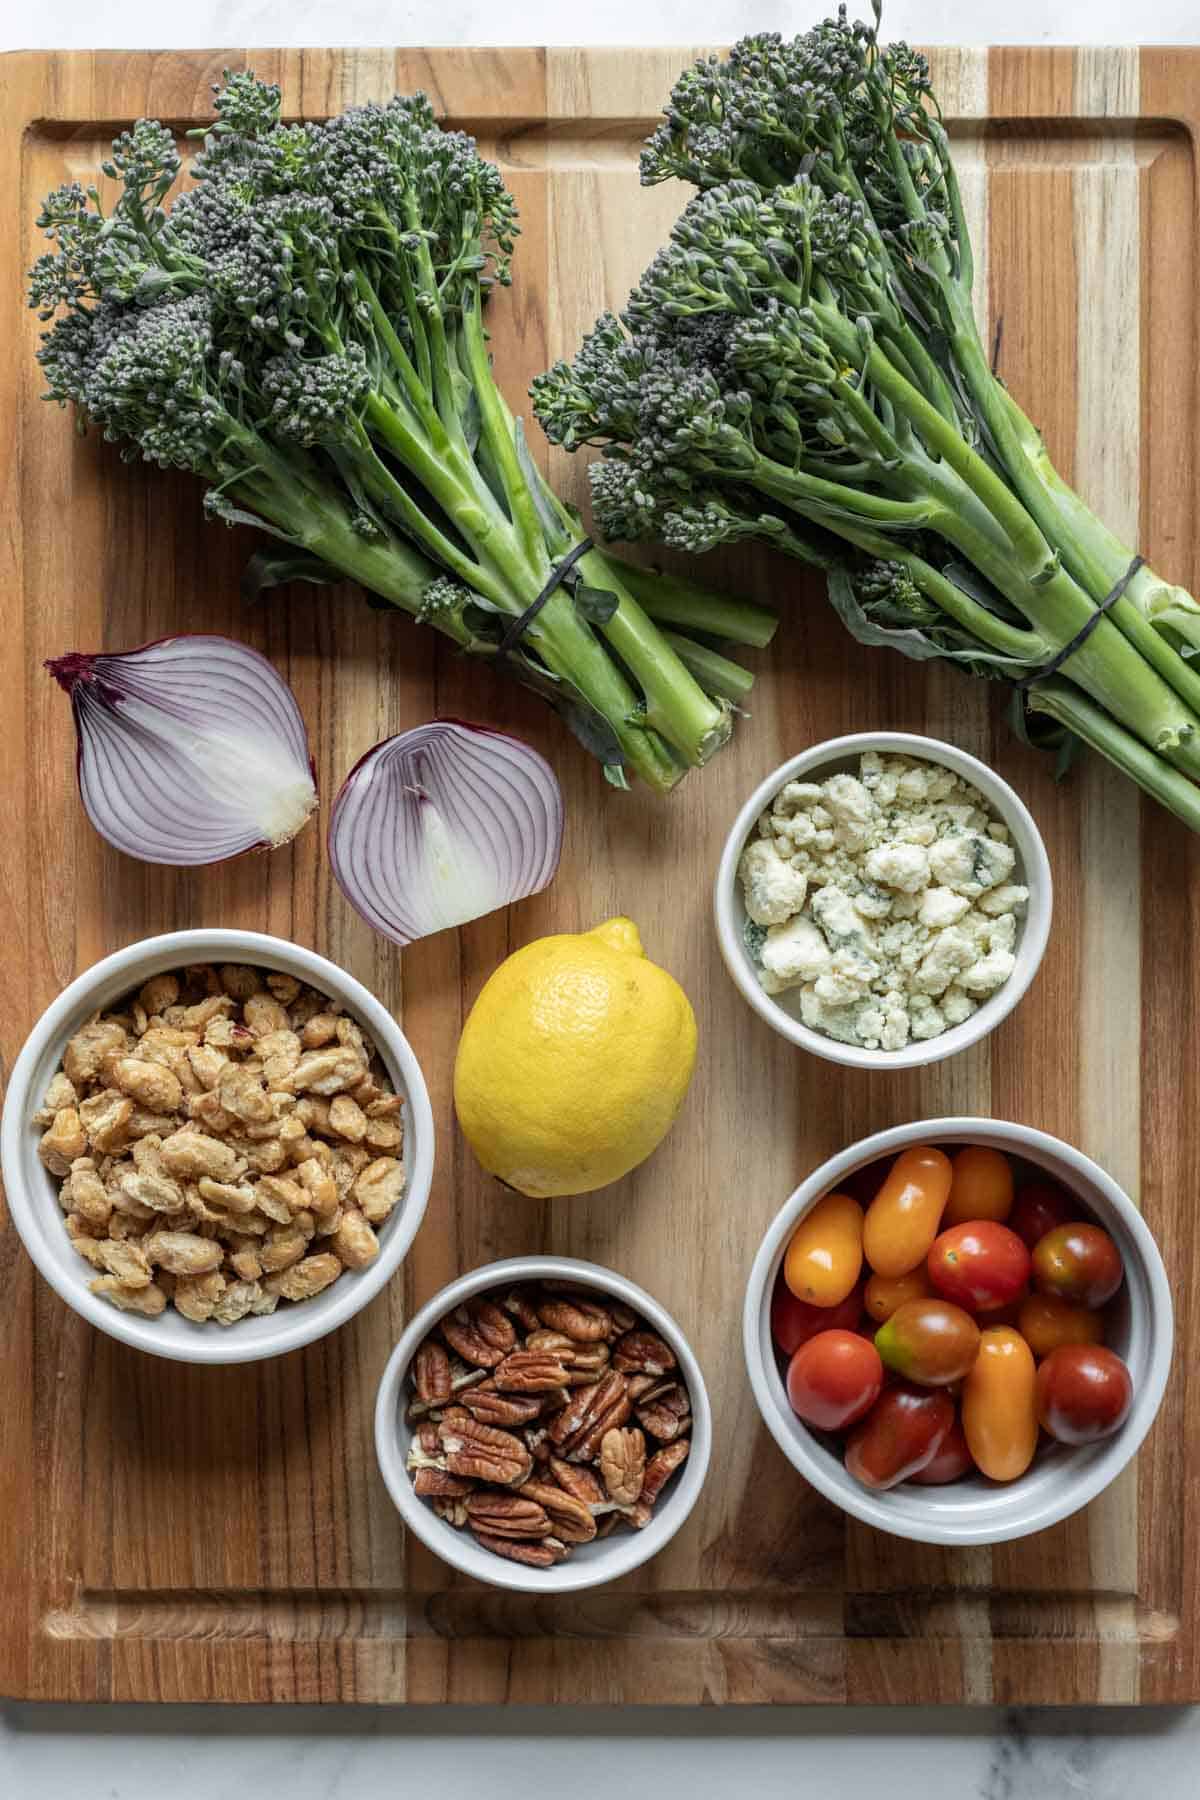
{"left": 0, "top": 38, "right": 1200, "bottom": 1703}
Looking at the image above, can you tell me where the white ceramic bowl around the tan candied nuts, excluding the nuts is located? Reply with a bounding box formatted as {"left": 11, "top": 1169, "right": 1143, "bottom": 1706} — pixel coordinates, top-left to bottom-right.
{"left": 0, "top": 931, "right": 434, "bottom": 1363}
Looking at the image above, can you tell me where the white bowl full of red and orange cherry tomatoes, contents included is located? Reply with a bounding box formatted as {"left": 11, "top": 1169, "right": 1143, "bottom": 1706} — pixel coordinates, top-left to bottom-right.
{"left": 743, "top": 1118, "right": 1173, "bottom": 1544}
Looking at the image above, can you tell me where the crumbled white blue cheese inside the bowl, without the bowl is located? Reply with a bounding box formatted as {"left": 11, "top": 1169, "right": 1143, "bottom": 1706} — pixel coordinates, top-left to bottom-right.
{"left": 738, "top": 751, "right": 1029, "bottom": 1049}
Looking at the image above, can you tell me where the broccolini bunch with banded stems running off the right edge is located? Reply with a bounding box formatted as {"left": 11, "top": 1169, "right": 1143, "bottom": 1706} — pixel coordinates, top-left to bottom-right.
{"left": 534, "top": 0, "right": 1200, "bottom": 828}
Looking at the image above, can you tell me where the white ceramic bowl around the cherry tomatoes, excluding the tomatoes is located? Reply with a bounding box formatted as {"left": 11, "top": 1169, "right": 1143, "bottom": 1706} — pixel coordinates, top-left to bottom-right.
{"left": 743, "top": 1118, "right": 1173, "bottom": 1544}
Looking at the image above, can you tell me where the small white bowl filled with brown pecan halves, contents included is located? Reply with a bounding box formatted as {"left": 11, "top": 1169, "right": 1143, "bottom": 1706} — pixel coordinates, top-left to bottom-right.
{"left": 374, "top": 1256, "right": 712, "bottom": 1593}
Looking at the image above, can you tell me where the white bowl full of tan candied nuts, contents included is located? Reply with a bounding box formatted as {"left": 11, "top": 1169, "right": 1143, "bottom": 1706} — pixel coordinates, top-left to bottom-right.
{"left": 2, "top": 931, "right": 434, "bottom": 1363}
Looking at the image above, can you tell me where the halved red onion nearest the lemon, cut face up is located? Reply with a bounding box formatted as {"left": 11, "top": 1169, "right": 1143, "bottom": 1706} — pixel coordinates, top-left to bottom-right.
{"left": 329, "top": 718, "right": 563, "bottom": 943}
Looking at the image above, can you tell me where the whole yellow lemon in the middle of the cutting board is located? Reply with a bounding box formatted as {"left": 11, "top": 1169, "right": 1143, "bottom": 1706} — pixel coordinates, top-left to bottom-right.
{"left": 453, "top": 918, "right": 696, "bottom": 1199}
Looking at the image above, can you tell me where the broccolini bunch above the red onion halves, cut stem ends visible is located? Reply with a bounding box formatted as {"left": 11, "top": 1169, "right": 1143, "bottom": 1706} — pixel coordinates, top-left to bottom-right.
{"left": 31, "top": 72, "right": 772, "bottom": 788}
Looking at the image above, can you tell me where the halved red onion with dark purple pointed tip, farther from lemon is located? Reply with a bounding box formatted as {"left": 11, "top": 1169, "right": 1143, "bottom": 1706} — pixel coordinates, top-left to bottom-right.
{"left": 47, "top": 635, "right": 317, "bottom": 868}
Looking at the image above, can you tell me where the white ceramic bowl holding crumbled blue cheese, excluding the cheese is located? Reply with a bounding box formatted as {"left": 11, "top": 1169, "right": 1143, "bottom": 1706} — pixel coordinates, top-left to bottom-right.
{"left": 712, "top": 731, "right": 1052, "bottom": 1069}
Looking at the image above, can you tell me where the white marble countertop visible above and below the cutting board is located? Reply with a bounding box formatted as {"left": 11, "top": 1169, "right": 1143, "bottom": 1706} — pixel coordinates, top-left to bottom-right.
{"left": 0, "top": 0, "right": 1200, "bottom": 1800}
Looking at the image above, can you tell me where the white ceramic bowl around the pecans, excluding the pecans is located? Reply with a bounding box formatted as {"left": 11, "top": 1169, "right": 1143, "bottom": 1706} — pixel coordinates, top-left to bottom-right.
{"left": 374, "top": 1256, "right": 712, "bottom": 1593}
